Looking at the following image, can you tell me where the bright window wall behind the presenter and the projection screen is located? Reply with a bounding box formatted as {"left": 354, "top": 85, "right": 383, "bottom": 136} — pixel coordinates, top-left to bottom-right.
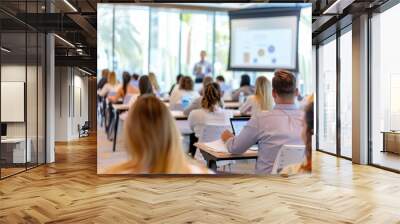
{"left": 97, "top": 4, "right": 314, "bottom": 95}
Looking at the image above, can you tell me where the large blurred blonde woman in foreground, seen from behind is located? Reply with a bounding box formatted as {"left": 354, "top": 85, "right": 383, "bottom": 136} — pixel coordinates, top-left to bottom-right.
{"left": 107, "top": 95, "right": 210, "bottom": 174}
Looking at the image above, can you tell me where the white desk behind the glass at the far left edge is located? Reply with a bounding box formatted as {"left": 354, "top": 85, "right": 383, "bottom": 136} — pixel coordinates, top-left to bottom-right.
{"left": 1, "top": 138, "right": 32, "bottom": 163}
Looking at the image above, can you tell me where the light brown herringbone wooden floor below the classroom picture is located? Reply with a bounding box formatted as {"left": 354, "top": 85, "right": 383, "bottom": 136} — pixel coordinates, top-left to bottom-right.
{"left": 0, "top": 134, "right": 400, "bottom": 224}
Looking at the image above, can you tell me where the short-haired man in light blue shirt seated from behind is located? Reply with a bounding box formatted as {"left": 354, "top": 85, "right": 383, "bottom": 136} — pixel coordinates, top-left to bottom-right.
{"left": 221, "top": 70, "right": 304, "bottom": 174}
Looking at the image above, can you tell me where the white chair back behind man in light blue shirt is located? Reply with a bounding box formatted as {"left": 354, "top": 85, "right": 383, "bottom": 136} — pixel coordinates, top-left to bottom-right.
{"left": 271, "top": 145, "right": 306, "bottom": 174}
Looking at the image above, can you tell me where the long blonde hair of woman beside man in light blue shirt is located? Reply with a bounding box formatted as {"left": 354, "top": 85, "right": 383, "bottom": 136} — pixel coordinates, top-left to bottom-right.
{"left": 255, "top": 76, "right": 272, "bottom": 110}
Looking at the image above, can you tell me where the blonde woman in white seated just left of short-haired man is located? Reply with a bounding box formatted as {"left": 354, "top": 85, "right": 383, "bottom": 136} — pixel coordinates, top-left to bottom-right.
{"left": 239, "top": 76, "right": 273, "bottom": 115}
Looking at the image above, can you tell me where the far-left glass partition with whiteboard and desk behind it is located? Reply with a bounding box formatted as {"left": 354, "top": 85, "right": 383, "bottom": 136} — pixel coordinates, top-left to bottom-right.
{"left": 0, "top": 1, "right": 46, "bottom": 179}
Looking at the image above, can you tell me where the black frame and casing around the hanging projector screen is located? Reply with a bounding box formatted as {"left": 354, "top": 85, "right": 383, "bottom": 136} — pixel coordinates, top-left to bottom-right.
{"left": 227, "top": 6, "right": 303, "bottom": 73}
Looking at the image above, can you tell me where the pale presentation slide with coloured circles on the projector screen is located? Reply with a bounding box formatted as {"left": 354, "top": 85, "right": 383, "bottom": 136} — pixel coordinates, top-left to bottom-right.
{"left": 230, "top": 16, "right": 298, "bottom": 70}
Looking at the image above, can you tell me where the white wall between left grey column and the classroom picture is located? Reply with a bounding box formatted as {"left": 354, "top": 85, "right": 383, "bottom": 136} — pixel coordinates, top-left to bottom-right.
{"left": 55, "top": 67, "right": 88, "bottom": 141}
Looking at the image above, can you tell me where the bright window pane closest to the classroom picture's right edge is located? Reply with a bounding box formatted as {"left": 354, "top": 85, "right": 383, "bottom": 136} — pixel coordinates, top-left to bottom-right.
{"left": 318, "top": 39, "right": 336, "bottom": 153}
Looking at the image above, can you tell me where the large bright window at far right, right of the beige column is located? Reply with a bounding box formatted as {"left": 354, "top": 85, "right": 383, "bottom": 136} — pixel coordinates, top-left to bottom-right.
{"left": 370, "top": 4, "right": 400, "bottom": 170}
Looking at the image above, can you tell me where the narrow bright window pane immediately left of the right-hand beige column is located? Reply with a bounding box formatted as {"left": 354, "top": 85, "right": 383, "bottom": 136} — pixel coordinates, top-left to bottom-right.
{"left": 340, "top": 31, "right": 353, "bottom": 158}
